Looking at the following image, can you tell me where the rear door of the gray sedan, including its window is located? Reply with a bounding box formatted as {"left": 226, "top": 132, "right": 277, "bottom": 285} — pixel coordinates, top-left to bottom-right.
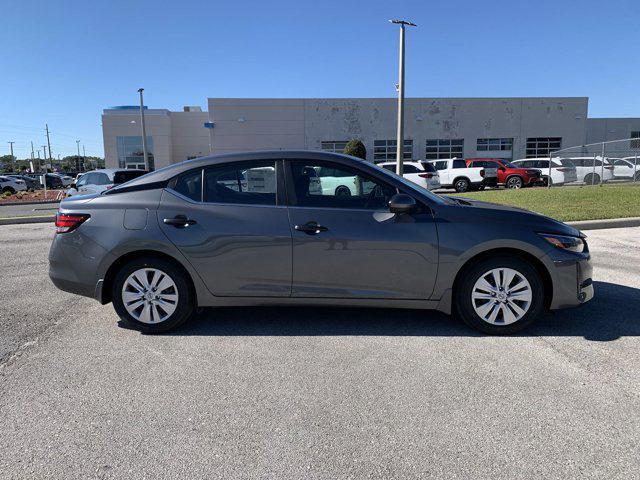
{"left": 158, "top": 160, "right": 291, "bottom": 297}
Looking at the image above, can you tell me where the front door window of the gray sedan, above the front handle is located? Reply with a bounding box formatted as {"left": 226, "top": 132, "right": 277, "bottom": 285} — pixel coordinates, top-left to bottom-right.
{"left": 290, "top": 160, "right": 397, "bottom": 210}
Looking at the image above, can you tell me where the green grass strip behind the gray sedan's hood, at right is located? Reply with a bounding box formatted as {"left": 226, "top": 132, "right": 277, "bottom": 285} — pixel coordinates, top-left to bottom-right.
{"left": 455, "top": 184, "right": 640, "bottom": 222}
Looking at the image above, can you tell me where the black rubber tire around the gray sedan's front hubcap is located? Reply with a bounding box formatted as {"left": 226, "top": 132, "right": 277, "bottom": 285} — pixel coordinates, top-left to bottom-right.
{"left": 454, "top": 255, "right": 544, "bottom": 335}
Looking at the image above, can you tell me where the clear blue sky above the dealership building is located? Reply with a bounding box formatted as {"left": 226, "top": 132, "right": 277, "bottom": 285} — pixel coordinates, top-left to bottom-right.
{"left": 0, "top": 0, "right": 640, "bottom": 157}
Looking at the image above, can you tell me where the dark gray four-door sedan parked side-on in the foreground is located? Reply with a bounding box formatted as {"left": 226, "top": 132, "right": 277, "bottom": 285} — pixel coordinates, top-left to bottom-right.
{"left": 49, "top": 151, "right": 593, "bottom": 334}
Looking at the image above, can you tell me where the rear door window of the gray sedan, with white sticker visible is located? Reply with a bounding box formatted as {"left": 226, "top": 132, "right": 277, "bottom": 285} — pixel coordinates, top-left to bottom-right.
{"left": 204, "top": 160, "right": 276, "bottom": 205}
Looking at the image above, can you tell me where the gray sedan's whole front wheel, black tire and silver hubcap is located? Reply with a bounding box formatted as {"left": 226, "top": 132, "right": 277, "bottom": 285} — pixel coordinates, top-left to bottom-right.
{"left": 456, "top": 255, "right": 544, "bottom": 335}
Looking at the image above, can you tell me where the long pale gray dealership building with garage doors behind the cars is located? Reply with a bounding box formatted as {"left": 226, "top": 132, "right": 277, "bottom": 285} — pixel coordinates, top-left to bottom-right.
{"left": 102, "top": 97, "right": 640, "bottom": 168}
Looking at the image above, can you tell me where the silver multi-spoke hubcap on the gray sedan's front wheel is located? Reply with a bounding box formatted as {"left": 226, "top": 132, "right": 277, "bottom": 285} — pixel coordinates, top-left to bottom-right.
{"left": 471, "top": 268, "right": 533, "bottom": 325}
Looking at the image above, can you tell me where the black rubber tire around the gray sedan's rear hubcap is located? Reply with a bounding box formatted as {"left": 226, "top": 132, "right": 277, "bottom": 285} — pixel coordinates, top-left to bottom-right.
{"left": 112, "top": 257, "right": 195, "bottom": 333}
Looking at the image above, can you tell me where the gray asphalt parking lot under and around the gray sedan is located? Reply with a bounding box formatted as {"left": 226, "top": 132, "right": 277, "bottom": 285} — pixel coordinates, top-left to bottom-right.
{"left": 0, "top": 224, "right": 640, "bottom": 479}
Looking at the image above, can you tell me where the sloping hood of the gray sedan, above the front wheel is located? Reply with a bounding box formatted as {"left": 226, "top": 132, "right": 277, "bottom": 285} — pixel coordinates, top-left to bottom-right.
{"left": 444, "top": 195, "right": 582, "bottom": 237}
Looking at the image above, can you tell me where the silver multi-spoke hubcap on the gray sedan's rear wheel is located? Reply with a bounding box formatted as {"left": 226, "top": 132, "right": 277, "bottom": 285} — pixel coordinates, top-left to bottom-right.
{"left": 122, "top": 268, "right": 178, "bottom": 323}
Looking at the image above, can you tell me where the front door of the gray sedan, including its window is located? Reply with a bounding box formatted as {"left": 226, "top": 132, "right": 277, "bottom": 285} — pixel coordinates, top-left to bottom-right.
{"left": 286, "top": 160, "right": 438, "bottom": 299}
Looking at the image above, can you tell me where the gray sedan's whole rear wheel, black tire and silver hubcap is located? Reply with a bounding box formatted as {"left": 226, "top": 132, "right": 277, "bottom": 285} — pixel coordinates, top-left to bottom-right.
{"left": 112, "top": 258, "right": 194, "bottom": 333}
